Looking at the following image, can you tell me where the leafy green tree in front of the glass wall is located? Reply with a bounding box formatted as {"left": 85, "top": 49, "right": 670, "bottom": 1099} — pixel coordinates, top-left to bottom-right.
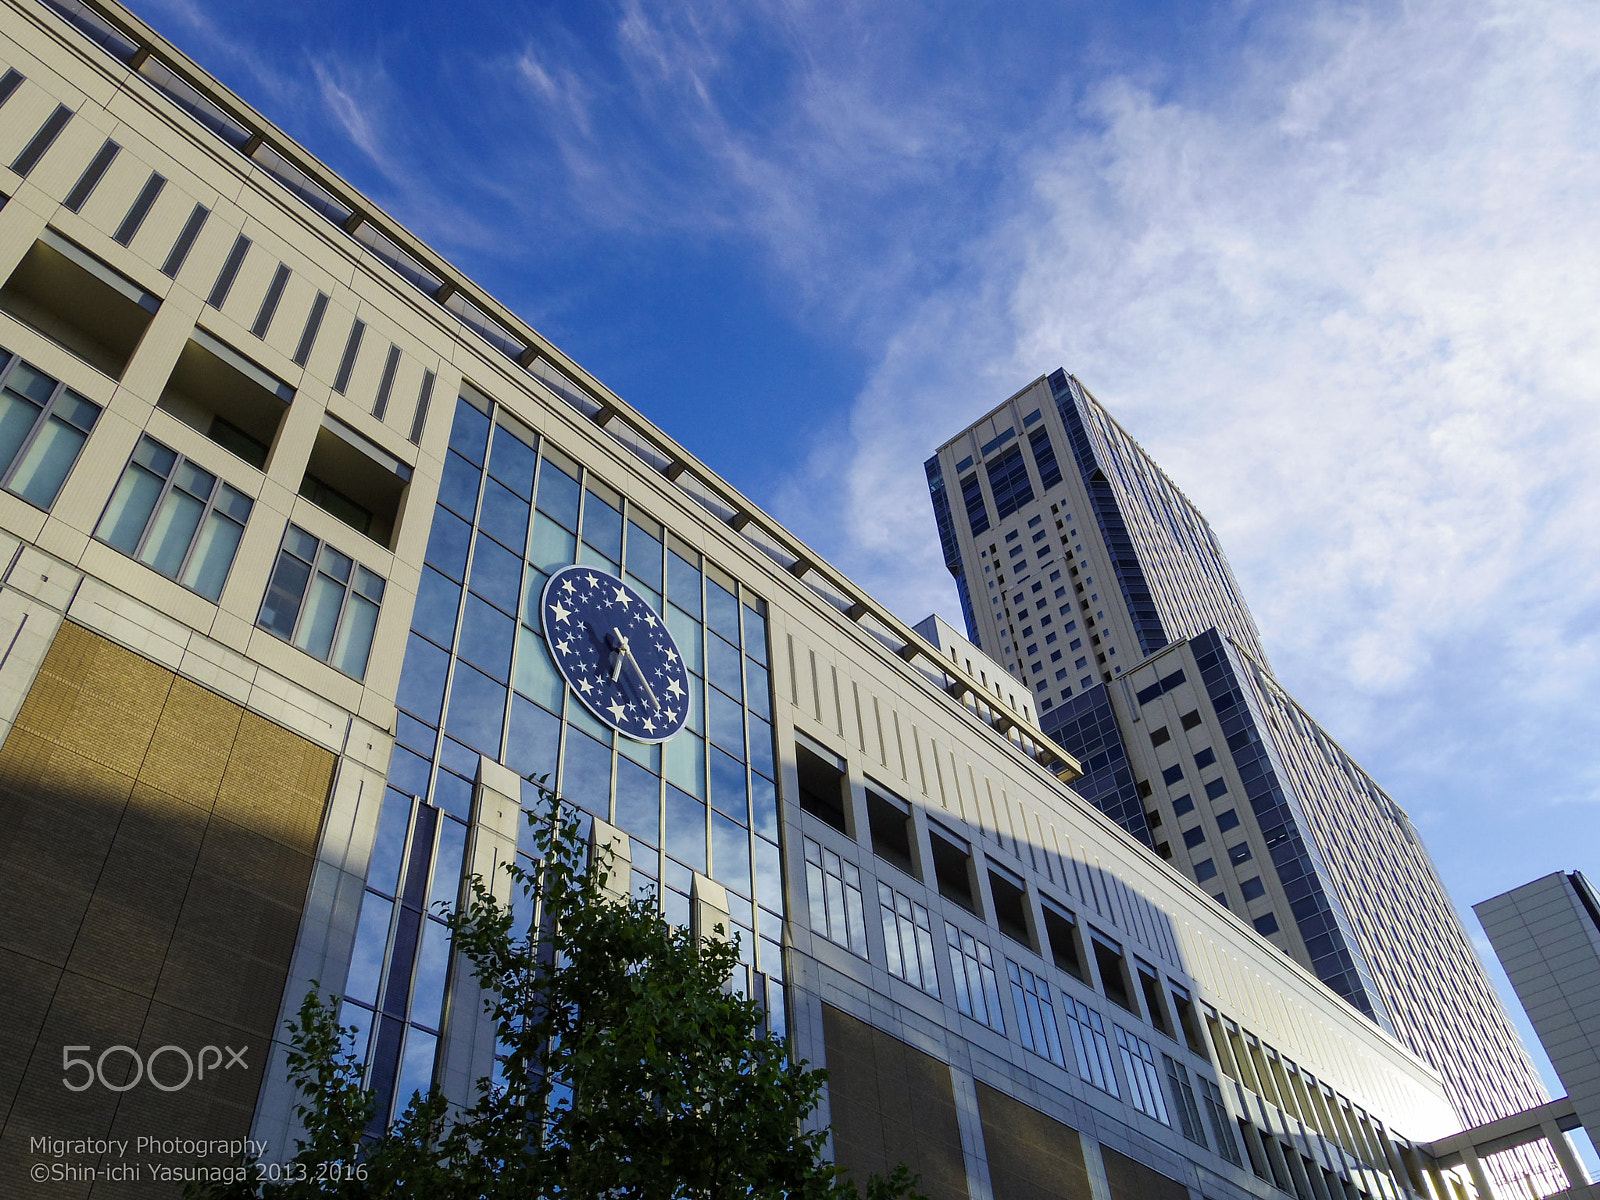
{"left": 190, "top": 790, "right": 915, "bottom": 1200}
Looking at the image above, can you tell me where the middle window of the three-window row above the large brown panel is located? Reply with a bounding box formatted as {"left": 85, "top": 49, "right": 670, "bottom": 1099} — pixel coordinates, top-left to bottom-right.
{"left": 94, "top": 437, "right": 249, "bottom": 601}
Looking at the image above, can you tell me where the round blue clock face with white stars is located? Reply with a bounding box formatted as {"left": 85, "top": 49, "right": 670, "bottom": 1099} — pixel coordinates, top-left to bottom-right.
{"left": 539, "top": 565, "right": 690, "bottom": 742}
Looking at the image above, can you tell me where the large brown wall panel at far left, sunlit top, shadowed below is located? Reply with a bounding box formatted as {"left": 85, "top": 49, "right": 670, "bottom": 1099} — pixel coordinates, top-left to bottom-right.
{"left": 0, "top": 622, "right": 334, "bottom": 1197}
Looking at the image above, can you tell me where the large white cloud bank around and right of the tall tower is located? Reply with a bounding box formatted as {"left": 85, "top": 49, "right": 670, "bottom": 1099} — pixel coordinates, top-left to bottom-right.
{"left": 779, "top": 0, "right": 1600, "bottom": 864}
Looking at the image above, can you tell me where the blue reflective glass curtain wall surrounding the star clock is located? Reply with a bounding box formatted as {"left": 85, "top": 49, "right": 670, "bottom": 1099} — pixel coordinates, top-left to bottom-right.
{"left": 341, "top": 397, "right": 787, "bottom": 1118}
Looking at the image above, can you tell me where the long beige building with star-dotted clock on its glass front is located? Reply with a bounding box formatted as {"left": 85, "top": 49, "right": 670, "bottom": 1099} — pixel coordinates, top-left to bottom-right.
{"left": 0, "top": 0, "right": 1561, "bottom": 1200}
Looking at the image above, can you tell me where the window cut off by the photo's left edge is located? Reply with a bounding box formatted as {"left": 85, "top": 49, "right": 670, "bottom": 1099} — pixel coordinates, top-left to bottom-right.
{"left": 0, "top": 350, "right": 100, "bottom": 512}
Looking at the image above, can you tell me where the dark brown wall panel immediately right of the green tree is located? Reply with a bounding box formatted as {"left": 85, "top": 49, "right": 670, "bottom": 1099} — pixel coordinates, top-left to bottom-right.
{"left": 822, "top": 1005, "right": 966, "bottom": 1200}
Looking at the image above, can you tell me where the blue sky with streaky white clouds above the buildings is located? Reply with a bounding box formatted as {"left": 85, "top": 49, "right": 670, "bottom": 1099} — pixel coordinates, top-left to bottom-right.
{"left": 134, "top": 0, "right": 1600, "bottom": 1126}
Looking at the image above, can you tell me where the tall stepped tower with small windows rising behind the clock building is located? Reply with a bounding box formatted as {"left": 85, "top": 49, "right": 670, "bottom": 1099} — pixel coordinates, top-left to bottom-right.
{"left": 925, "top": 371, "right": 1544, "bottom": 1123}
